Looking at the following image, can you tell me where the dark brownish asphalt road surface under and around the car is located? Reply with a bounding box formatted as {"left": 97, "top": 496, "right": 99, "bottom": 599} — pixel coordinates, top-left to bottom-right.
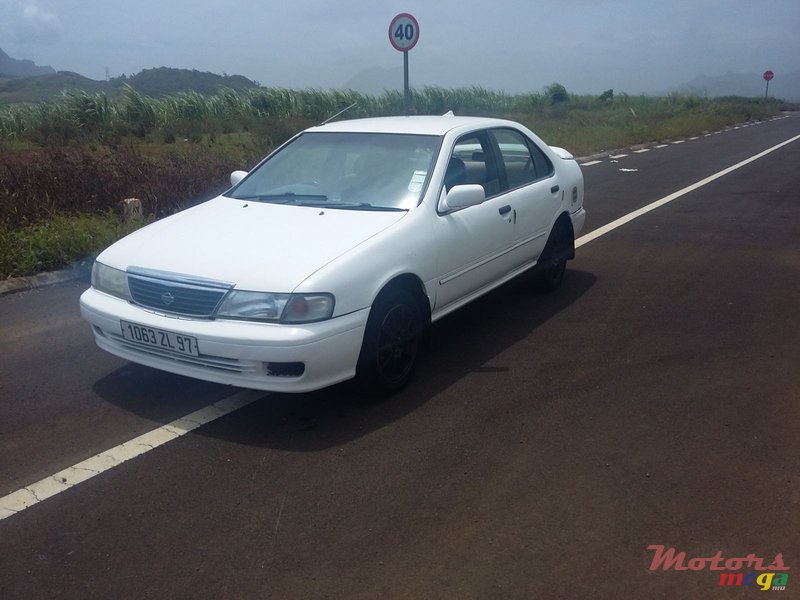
{"left": 0, "top": 115, "right": 800, "bottom": 600}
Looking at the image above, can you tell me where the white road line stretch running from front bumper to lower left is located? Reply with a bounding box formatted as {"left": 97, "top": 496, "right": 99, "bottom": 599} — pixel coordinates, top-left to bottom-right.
{"left": 0, "top": 390, "right": 267, "bottom": 521}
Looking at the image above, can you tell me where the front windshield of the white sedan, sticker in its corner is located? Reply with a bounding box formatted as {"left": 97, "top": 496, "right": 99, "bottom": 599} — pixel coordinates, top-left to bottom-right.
{"left": 226, "top": 132, "right": 441, "bottom": 210}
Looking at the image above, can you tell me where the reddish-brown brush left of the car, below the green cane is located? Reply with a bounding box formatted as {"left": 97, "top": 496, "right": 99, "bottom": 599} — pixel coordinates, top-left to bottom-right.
{"left": 0, "top": 144, "right": 261, "bottom": 230}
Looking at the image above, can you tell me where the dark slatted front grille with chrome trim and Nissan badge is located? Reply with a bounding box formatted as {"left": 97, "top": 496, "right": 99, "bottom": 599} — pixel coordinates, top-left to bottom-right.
{"left": 128, "top": 267, "right": 233, "bottom": 318}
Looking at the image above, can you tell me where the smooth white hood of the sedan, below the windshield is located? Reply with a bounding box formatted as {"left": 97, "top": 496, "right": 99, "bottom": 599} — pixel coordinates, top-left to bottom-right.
{"left": 97, "top": 196, "right": 407, "bottom": 292}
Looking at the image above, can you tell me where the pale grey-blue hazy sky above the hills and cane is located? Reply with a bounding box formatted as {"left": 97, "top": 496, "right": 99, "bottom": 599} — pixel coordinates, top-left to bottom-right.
{"left": 0, "top": 0, "right": 800, "bottom": 94}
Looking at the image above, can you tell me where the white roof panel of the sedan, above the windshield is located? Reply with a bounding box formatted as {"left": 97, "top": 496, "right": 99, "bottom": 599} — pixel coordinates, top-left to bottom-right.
{"left": 306, "top": 115, "right": 518, "bottom": 135}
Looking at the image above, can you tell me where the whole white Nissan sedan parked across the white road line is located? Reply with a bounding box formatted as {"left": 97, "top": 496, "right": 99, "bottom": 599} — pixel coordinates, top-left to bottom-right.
{"left": 80, "top": 115, "right": 586, "bottom": 393}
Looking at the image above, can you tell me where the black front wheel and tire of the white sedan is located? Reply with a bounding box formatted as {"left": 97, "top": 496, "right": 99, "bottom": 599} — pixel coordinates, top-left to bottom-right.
{"left": 356, "top": 288, "right": 424, "bottom": 396}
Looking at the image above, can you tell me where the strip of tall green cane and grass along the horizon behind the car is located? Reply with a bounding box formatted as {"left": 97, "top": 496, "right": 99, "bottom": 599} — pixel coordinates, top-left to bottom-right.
{"left": 0, "top": 83, "right": 780, "bottom": 154}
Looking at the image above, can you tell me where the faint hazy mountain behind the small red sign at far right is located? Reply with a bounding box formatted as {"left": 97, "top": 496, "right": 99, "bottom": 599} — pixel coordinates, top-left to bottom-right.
{"left": 679, "top": 71, "right": 800, "bottom": 101}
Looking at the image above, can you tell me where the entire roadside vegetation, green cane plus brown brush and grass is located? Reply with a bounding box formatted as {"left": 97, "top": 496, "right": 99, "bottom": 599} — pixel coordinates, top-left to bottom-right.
{"left": 0, "top": 81, "right": 780, "bottom": 278}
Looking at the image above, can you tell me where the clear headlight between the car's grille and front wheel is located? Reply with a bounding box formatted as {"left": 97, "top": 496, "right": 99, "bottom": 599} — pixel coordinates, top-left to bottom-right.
{"left": 217, "top": 290, "right": 334, "bottom": 323}
